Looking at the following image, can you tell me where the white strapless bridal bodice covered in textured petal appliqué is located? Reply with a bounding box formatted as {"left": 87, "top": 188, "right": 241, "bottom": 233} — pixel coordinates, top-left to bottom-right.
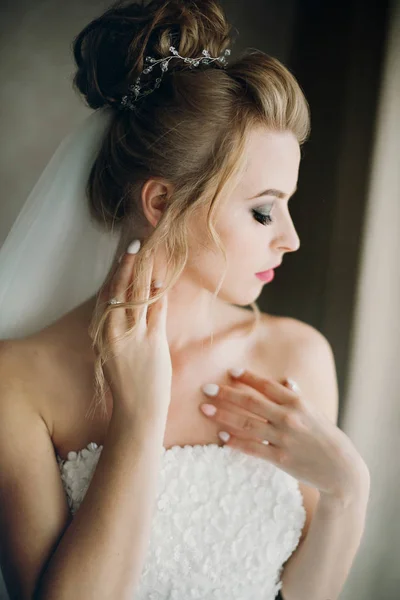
{"left": 57, "top": 443, "right": 306, "bottom": 600}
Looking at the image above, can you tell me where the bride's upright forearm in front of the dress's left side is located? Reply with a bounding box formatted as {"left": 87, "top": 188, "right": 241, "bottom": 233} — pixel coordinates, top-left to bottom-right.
{"left": 35, "top": 406, "right": 165, "bottom": 600}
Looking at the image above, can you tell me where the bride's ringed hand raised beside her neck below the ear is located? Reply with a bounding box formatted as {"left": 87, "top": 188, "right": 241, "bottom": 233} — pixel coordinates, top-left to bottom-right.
{"left": 97, "top": 240, "right": 172, "bottom": 416}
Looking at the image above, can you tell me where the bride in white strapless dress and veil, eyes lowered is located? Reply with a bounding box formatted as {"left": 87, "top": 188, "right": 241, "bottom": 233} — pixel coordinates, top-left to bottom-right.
{"left": 0, "top": 0, "right": 369, "bottom": 600}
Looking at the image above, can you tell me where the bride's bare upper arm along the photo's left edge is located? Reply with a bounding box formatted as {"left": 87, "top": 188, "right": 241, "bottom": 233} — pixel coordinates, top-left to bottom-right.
{"left": 0, "top": 340, "right": 70, "bottom": 599}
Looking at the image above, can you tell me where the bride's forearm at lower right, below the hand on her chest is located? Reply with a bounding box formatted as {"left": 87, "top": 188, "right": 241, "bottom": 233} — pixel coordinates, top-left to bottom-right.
{"left": 281, "top": 479, "right": 369, "bottom": 600}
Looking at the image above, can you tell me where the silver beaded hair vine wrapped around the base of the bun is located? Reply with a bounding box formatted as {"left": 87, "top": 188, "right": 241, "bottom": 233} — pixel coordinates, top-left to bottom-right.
{"left": 120, "top": 46, "right": 231, "bottom": 110}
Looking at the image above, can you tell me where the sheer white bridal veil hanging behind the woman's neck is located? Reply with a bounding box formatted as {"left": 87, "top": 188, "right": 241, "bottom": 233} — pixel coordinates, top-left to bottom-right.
{"left": 0, "top": 107, "right": 120, "bottom": 339}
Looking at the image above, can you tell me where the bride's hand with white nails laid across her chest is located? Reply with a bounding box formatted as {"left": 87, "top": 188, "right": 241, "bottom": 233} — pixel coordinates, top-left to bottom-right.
{"left": 202, "top": 370, "right": 367, "bottom": 497}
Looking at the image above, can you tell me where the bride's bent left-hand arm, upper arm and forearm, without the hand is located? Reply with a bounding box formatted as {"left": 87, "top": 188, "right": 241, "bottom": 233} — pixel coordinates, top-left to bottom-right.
{"left": 0, "top": 342, "right": 166, "bottom": 600}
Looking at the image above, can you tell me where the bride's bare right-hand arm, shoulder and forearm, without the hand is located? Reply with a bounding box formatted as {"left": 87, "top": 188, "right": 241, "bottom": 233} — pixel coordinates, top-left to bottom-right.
{"left": 280, "top": 322, "right": 370, "bottom": 600}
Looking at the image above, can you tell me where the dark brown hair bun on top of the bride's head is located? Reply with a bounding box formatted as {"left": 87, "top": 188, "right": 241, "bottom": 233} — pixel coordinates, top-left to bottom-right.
{"left": 73, "top": 0, "right": 231, "bottom": 109}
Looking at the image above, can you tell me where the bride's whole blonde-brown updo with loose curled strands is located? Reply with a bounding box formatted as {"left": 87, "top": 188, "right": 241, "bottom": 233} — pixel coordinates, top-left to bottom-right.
{"left": 73, "top": 0, "right": 310, "bottom": 420}
